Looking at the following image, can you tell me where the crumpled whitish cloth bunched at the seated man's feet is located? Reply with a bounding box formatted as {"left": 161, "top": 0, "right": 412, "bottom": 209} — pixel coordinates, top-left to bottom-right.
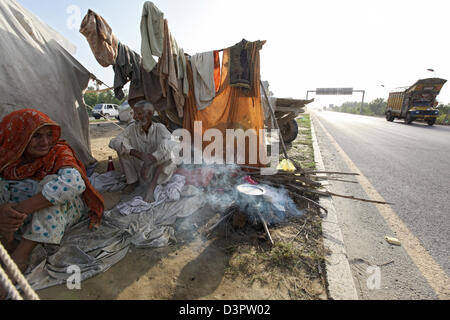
{"left": 117, "top": 174, "right": 186, "bottom": 216}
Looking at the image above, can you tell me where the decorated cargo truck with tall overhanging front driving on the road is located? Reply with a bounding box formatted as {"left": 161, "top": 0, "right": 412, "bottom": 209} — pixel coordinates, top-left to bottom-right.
{"left": 385, "top": 78, "right": 447, "bottom": 126}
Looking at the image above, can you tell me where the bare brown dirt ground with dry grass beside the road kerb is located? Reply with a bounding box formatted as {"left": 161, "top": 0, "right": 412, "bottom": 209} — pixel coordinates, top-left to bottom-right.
{"left": 37, "top": 117, "right": 327, "bottom": 300}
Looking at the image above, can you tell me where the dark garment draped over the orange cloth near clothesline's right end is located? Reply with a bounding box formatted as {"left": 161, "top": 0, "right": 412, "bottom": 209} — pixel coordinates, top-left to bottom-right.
{"left": 230, "top": 39, "right": 252, "bottom": 89}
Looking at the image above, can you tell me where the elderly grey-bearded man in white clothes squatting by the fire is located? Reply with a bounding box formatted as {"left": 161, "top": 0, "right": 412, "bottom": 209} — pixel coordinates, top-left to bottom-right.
{"left": 109, "top": 101, "right": 177, "bottom": 203}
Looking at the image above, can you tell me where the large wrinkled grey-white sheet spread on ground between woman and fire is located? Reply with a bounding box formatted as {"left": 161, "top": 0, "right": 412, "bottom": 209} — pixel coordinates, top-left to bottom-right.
{"left": 25, "top": 185, "right": 206, "bottom": 290}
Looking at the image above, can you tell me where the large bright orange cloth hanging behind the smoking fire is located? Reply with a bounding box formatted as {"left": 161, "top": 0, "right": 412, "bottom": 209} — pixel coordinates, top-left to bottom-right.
{"left": 183, "top": 41, "right": 269, "bottom": 167}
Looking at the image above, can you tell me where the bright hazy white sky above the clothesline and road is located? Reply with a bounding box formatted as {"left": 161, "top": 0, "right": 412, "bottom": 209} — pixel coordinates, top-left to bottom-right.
{"left": 18, "top": 0, "right": 450, "bottom": 107}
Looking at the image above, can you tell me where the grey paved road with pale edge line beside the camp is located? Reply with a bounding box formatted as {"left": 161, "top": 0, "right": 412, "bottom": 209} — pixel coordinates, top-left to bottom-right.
{"left": 313, "top": 112, "right": 450, "bottom": 299}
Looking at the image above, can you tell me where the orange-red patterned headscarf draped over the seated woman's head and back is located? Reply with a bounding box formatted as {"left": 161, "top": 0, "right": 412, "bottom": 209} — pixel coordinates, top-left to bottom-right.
{"left": 0, "top": 109, "right": 104, "bottom": 227}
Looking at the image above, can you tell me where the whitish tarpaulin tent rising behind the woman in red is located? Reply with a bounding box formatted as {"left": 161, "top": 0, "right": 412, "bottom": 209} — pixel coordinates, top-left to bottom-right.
{"left": 0, "top": 0, "right": 95, "bottom": 166}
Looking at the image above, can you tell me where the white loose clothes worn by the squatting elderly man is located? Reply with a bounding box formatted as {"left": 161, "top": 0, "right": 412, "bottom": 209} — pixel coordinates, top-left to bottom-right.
{"left": 109, "top": 122, "right": 177, "bottom": 184}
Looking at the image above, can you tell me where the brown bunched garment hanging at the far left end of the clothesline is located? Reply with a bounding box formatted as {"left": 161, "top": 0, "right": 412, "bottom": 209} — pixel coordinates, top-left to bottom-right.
{"left": 80, "top": 10, "right": 119, "bottom": 68}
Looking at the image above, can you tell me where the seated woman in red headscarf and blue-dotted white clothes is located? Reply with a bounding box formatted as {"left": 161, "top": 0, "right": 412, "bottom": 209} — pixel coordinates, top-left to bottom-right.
{"left": 0, "top": 109, "right": 104, "bottom": 278}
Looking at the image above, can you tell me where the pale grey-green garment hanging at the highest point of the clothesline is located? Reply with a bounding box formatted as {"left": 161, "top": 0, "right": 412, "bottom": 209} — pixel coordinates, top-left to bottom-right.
{"left": 141, "top": 1, "right": 164, "bottom": 72}
